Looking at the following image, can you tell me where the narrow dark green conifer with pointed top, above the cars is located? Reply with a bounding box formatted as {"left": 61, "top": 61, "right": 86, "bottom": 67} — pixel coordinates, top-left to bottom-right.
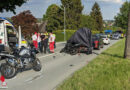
{"left": 90, "top": 2, "right": 103, "bottom": 31}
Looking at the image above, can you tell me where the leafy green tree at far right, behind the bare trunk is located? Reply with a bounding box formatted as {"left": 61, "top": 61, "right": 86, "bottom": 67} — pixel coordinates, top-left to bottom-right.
{"left": 115, "top": 1, "right": 130, "bottom": 29}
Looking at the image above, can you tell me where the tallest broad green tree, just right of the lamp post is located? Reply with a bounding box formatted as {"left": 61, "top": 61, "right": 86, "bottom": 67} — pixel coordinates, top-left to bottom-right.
{"left": 61, "top": 0, "right": 83, "bottom": 29}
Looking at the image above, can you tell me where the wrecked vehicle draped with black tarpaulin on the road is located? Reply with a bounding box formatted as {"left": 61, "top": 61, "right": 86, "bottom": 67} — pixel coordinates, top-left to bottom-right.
{"left": 60, "top": 28, "right": 92, "bottom": 55}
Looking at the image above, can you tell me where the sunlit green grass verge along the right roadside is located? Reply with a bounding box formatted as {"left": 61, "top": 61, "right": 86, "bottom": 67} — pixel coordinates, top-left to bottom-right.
{"left": 57, "top": 40, "right": 130, "bottom": 90}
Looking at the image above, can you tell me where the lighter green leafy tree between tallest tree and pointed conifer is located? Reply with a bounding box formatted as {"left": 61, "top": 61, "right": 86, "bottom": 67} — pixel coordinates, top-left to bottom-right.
{"left": 80, "top": 15, "right": 95, "bottom": 30}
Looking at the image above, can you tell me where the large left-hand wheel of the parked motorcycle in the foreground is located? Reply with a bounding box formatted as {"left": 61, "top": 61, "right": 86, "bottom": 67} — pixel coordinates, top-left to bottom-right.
{"left": 0, "top": 63, "right": 16, "bottom": 79}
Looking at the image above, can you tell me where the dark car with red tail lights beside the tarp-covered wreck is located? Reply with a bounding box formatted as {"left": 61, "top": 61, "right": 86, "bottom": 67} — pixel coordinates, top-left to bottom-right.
{"left": 92, "top": 35, "right": 104, "bottom": 50}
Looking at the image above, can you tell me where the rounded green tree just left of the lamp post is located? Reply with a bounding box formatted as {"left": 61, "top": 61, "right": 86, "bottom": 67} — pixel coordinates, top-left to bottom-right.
{"left": 43, "top": 4, "right": 63, "bottom": 30}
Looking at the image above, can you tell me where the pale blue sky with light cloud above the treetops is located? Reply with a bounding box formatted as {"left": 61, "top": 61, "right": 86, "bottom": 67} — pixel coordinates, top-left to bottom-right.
{"left": 0, "top": 0, "right": 126, "bottom": 20}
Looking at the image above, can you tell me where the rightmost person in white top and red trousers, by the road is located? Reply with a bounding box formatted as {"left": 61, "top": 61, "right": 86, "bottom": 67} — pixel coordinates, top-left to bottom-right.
{"left": 49, "top": 31, "right": 55, "bottom": 53}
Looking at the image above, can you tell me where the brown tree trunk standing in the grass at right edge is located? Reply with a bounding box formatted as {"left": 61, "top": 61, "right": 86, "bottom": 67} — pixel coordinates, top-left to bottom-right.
{"left": 124, "top": 12, "right": 130, "bottom": 59}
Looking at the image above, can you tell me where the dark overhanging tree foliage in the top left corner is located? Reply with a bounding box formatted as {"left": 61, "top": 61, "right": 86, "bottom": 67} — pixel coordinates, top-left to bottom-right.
{"left": 0, "top": 0, "right": 27, "bottom": 13}
